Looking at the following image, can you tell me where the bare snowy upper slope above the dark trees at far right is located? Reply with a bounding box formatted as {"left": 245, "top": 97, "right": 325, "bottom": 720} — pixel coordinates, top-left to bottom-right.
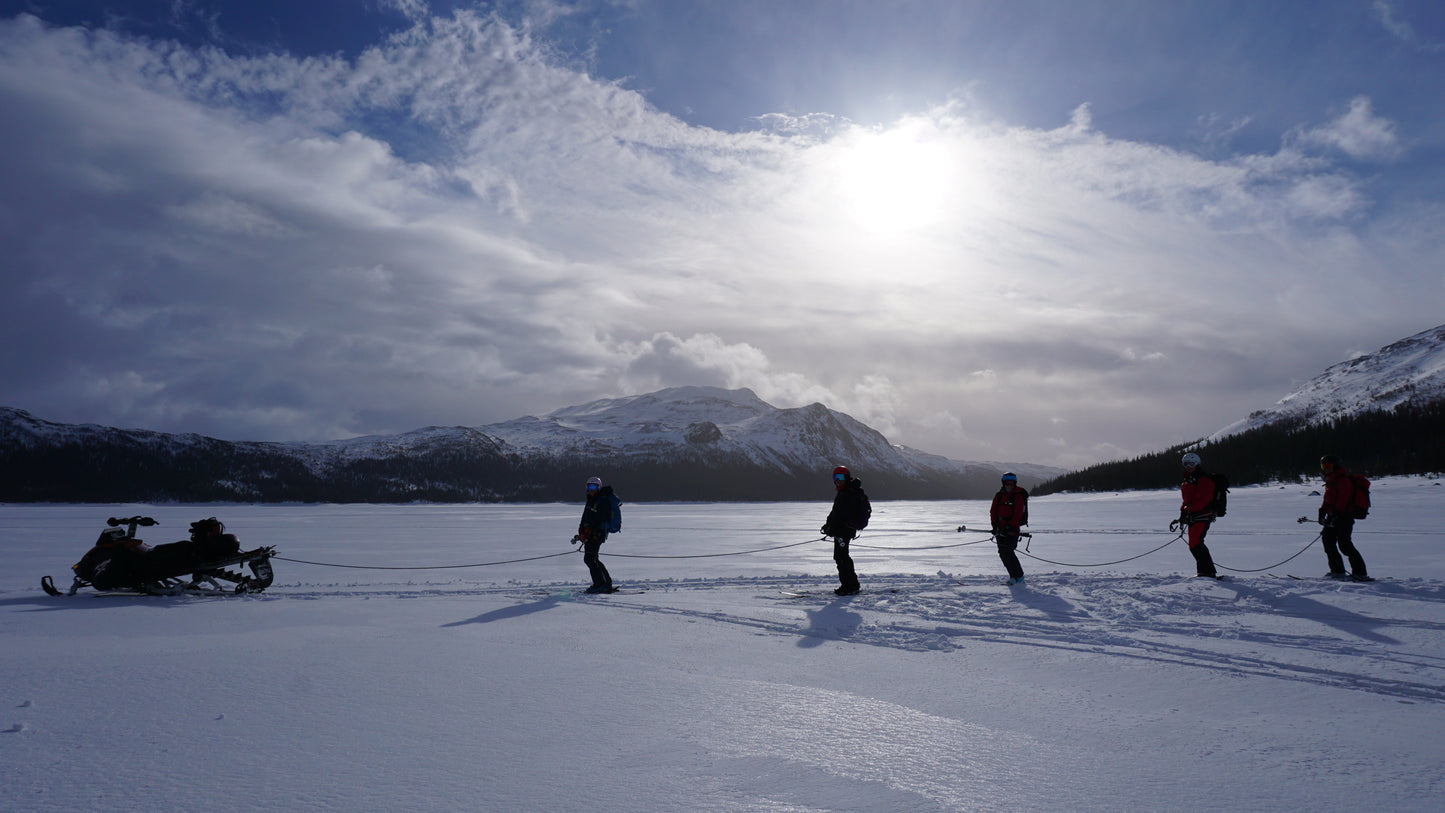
{"left": 1207, "top": 325, "right": 1445, "bottom": 442}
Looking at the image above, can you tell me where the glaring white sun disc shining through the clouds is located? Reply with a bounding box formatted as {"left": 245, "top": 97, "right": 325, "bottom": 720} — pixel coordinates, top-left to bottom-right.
{"left": 840, "top": 127, "right": 951, "bottom": 234}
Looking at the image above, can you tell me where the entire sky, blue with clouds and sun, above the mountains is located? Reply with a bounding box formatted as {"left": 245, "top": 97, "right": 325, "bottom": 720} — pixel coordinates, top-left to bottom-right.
{"left": 0, "top": 0, "right": 1445, "bottom": 466}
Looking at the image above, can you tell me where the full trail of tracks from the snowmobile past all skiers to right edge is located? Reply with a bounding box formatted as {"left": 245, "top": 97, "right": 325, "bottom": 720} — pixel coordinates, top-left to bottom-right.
{"left": 87, "top": 566, "right": 1445, "bottom": 702}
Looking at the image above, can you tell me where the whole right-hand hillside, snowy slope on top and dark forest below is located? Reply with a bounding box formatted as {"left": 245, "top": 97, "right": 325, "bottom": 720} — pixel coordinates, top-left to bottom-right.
{"left": 1035, "top": 326, "right": 1445, "bottom": 494}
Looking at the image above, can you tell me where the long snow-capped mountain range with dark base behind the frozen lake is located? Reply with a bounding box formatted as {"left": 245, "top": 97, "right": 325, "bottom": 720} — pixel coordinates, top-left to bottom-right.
{"left": 0, "top": 387, "right": 1059, "bottom": 501}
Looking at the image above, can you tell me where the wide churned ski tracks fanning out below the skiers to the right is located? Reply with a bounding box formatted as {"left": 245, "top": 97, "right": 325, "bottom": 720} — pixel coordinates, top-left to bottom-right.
{"left": 586, "top": 576, "right": 1445, "bottom": 702}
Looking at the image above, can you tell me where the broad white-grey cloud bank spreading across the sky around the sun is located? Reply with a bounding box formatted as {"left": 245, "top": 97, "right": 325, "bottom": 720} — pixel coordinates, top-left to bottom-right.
{"left": 0, "top": 11, "right": 1442, "bottom": 464}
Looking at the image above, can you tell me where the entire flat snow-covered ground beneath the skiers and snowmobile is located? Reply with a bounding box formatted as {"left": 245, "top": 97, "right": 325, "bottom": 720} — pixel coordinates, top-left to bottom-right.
{"left": 8, "top": 478, "right": 1445, "bottom": 813}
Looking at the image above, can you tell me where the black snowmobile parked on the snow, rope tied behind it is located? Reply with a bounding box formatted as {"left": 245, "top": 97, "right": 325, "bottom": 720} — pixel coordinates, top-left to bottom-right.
{"left": 40, "top": 517, "right": 276, "bottom": 595}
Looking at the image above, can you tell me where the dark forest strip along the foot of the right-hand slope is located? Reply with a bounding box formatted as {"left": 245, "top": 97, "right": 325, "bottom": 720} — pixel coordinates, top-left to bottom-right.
{"left": 1033, "top": 400, "right": 1445, "bottom": 495}
